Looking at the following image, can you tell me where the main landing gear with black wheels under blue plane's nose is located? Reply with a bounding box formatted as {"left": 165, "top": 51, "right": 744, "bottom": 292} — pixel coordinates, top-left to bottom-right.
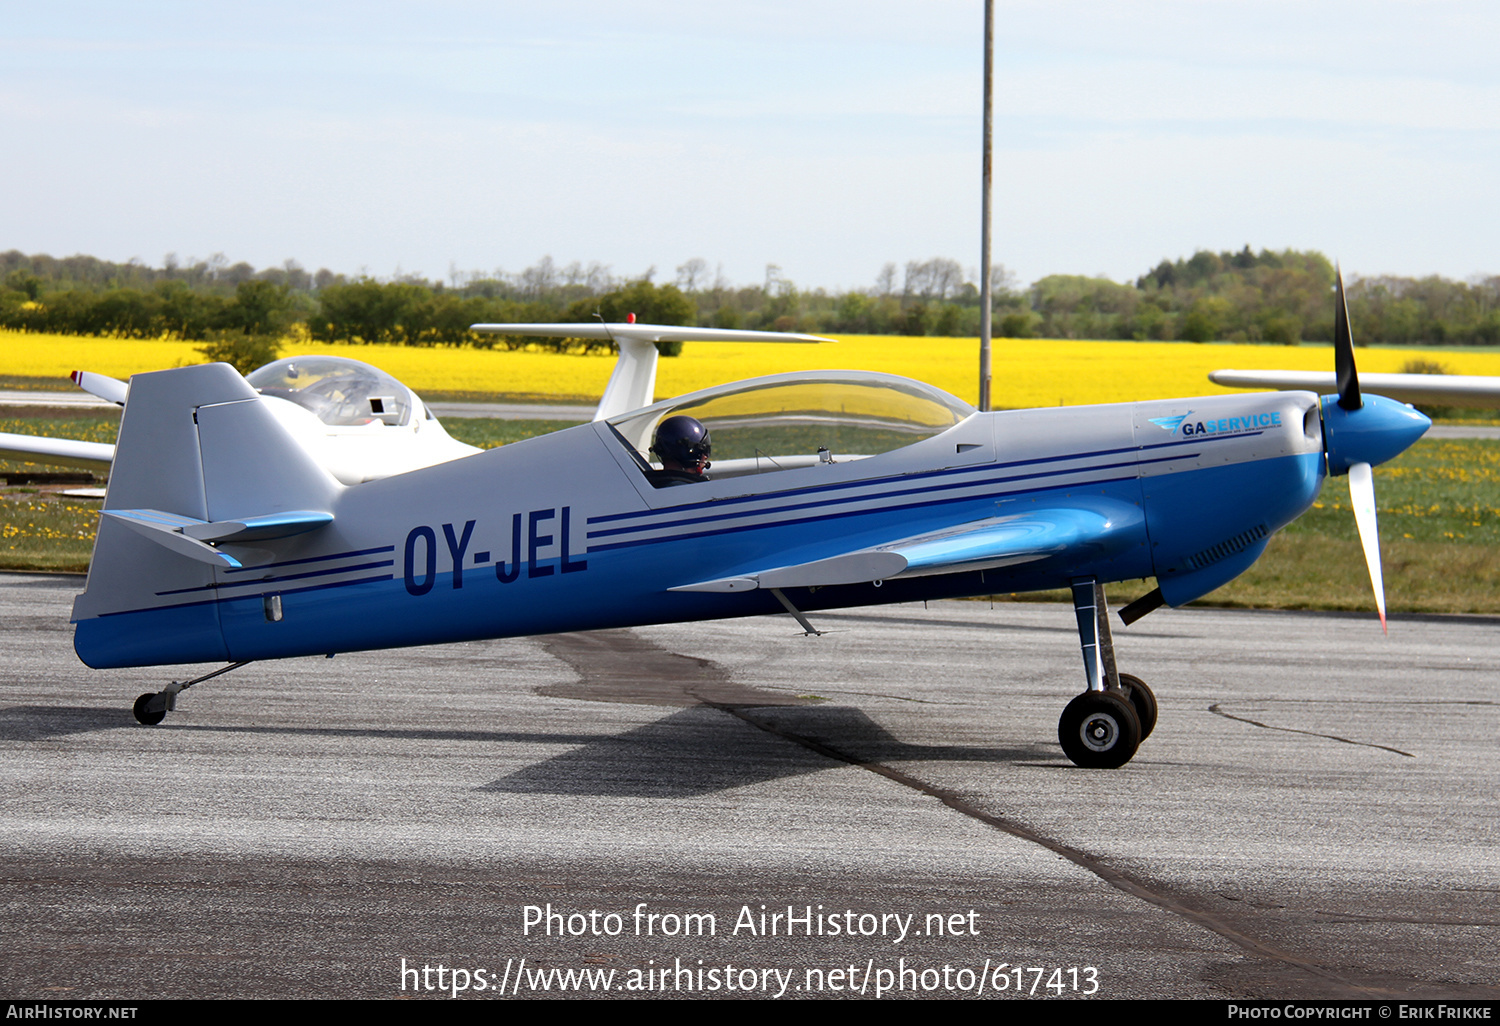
{"left": 1058, "top": 578, "right": 1157, "bottom": 770}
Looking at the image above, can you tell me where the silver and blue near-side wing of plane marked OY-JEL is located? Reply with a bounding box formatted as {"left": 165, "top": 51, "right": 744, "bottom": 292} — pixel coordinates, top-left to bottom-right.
{"left": 669, "top": 507, "right": 1140, "bottom": 591}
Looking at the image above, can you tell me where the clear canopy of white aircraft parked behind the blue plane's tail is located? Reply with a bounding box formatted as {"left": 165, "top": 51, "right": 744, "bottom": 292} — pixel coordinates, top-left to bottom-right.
{"left": 246, "top": 356, "right": 416, "bottom": 428}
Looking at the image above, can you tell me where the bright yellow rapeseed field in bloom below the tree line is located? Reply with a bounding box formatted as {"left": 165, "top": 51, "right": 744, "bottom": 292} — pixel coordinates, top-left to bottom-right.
{"left": 0, "top": 332, "right": 1500, "bottom": 408}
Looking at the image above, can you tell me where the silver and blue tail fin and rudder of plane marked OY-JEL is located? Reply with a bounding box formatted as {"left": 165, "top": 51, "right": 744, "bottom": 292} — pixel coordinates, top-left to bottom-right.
{"left": 74, "top": 363, "right": 342, "bottom": 668}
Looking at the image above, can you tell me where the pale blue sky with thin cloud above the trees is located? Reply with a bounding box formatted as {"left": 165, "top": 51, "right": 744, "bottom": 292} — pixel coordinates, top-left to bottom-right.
{"left": 0, "top": 0, "right": 1500, "bottom": 290}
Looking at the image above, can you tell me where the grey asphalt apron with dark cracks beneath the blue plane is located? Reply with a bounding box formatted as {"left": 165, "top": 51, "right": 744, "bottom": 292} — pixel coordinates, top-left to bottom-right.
{"left": 0, "top": 575, "right": 1500, "bottom": 1001}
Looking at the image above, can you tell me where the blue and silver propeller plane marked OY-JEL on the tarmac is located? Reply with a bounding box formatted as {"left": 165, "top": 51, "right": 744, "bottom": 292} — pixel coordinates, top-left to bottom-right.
{"left": 72, "top": 276, "right": 1430, "bottom": 767}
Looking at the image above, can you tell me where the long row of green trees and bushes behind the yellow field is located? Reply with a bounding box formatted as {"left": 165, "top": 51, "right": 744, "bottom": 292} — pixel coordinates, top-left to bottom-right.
{"left": 0, "top": 246, "right": 1500, "bottom": 351}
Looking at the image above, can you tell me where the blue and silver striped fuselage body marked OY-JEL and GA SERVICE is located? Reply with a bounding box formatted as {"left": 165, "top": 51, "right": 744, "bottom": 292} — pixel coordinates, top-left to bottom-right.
{"left": 75, "top": 393, "right": 1325, "bottom": 668}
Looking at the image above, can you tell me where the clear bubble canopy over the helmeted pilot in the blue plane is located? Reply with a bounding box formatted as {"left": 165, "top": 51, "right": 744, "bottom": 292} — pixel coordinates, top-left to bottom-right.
{"left": 609, "top": 371, "right": 975, "bottom": 479}
